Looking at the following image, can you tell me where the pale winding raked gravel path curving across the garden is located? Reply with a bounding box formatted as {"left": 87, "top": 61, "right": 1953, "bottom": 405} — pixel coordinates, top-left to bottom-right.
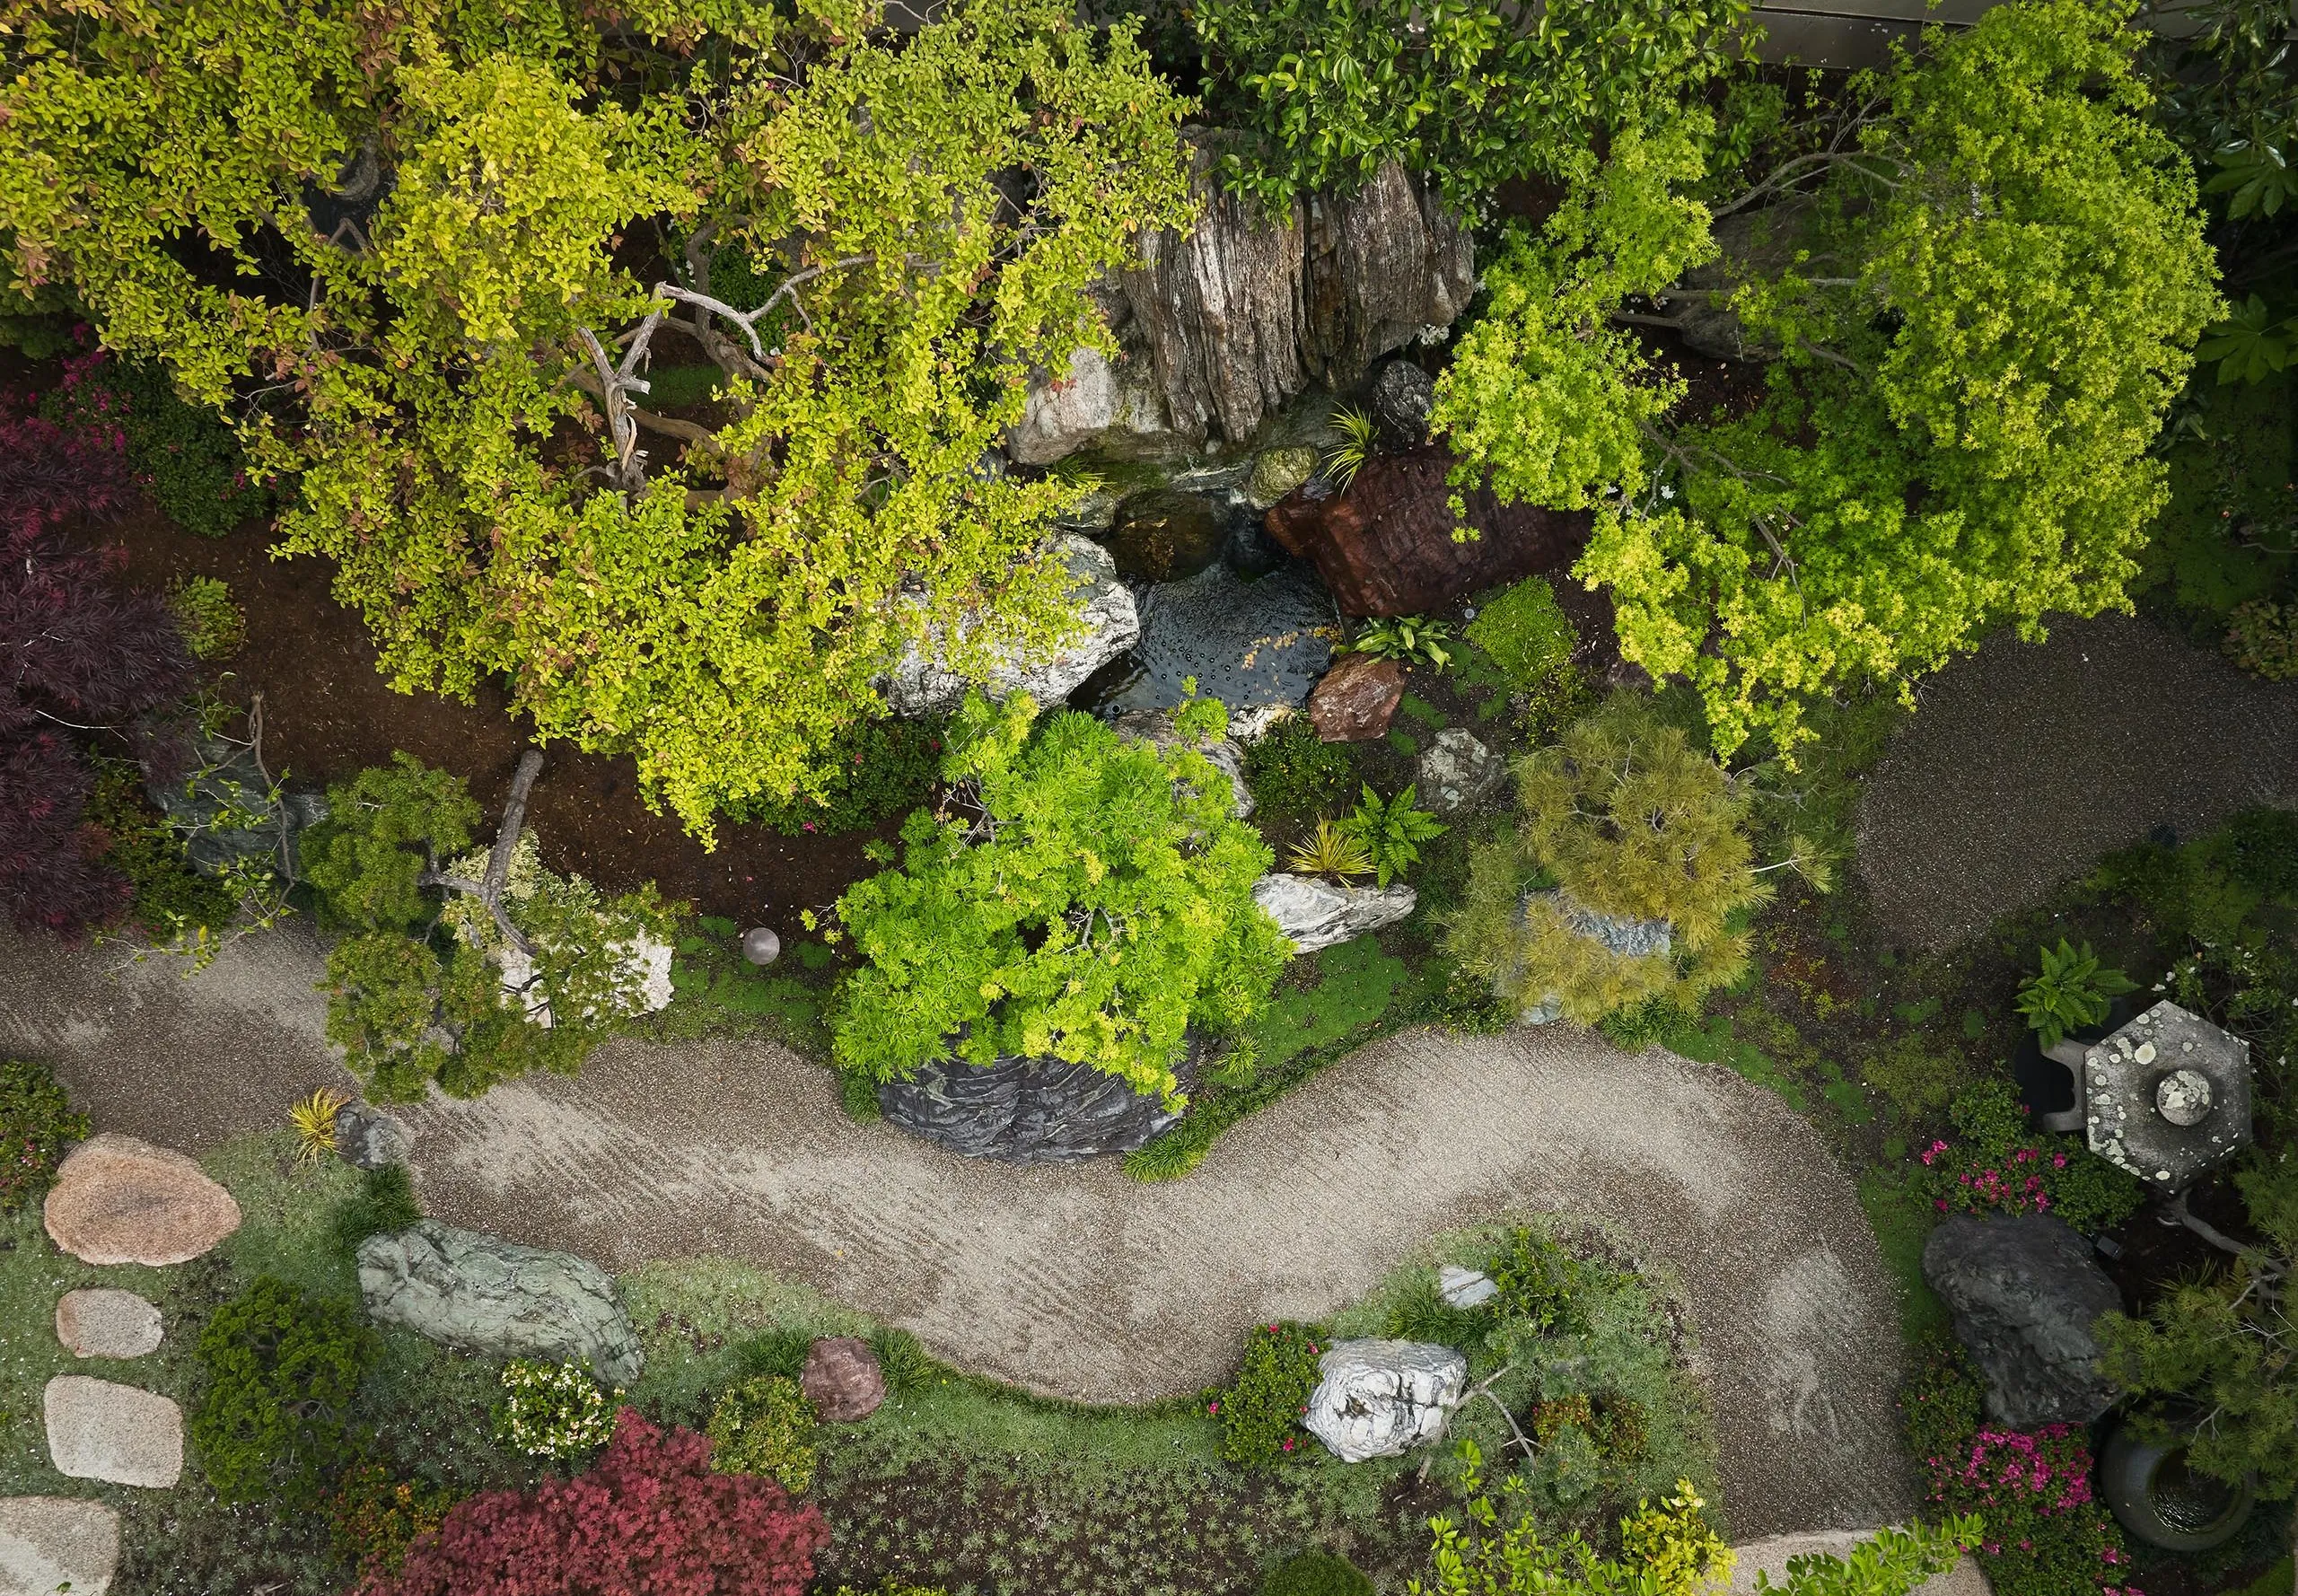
{"left": 0, "top": 928, "right": 1914, "bottom": 1539}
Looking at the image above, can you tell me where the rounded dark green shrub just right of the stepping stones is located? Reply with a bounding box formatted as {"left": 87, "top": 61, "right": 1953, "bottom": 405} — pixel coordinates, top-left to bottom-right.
{"left": 189, "top": 1276, "right": 374, "bottom": 1506}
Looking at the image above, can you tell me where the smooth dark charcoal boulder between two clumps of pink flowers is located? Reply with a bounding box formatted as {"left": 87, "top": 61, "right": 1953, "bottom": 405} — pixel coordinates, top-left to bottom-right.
{"left": 1924, "top": 1215, "right": 2123, "bottom": 1431}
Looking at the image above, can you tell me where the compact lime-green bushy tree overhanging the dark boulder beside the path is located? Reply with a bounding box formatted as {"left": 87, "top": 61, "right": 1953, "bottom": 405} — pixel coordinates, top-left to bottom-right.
{"left": 831, "top": 694, "right": 1289, "bottom": 1100}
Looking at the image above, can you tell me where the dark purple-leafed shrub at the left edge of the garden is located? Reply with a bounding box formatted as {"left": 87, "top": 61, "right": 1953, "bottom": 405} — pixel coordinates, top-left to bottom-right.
{"left": 0, "top": 388, "right": 190, "bottom": 937}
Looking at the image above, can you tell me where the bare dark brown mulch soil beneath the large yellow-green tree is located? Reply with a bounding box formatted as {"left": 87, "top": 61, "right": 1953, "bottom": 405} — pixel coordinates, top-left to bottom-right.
{"left": 103, "top": 500, "right": 873, "bottom": 930}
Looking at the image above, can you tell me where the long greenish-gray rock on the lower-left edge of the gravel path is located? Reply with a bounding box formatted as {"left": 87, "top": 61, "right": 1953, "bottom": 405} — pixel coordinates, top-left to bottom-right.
{"left": 358, "top": 1219, "right": 645, "bottom": 1390}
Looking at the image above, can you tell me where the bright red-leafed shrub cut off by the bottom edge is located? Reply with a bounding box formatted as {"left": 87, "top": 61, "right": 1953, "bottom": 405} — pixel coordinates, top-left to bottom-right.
{"left": 356, "top": 1407, "right": 829, "bottom": 1596}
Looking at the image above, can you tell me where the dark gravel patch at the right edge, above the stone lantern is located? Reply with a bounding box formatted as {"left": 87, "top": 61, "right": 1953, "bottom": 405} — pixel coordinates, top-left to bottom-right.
{"left": 1859, "top": 616, "right": 2298, "bottom": 949}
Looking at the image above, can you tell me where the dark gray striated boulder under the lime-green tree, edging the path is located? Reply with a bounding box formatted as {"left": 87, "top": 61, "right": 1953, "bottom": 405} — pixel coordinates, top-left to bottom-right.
{"left": 878, "top": 1054, "right": 1193, "bottom": 1164}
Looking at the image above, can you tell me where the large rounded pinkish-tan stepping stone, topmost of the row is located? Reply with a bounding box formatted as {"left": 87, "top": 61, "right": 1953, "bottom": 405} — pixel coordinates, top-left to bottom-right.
{"left": 46, "top": 1130, "right": 239, "bottom": 1263}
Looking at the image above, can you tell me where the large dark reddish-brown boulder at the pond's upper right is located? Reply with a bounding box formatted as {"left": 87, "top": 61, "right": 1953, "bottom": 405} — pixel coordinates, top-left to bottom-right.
{"left": 1267, "top": 448, "right": 1588, "bottom": 616}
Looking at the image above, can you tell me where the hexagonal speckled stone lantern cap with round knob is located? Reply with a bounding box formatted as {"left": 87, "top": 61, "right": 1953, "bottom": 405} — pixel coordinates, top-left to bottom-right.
{"left": 2082, "top": 1004, "right": 2250, "bottom": 1192}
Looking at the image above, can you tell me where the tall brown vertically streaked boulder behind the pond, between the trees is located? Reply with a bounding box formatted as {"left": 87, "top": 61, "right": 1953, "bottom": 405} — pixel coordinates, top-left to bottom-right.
{"left": 1006, "top": 128, "right": 1476, "bottom": 466}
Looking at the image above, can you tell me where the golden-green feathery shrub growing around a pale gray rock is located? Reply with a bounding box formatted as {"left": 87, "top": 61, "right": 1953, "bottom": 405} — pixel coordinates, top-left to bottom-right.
{"left": 1448, "top": 694, "right": 1767, "bottom": 1024}
